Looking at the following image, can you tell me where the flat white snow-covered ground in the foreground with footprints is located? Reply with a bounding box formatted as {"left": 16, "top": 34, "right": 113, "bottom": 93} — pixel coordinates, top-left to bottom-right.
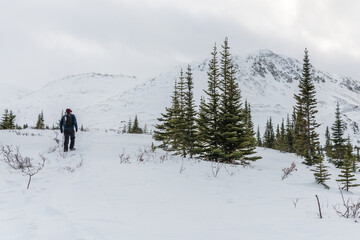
{"left": 0, "top": 130, "right": 360, "bottom": 240}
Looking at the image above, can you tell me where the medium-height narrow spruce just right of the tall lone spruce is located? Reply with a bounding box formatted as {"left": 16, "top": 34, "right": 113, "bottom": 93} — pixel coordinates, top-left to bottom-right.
{"left": 331, "top": 102, "right": 346, "bottom": 167}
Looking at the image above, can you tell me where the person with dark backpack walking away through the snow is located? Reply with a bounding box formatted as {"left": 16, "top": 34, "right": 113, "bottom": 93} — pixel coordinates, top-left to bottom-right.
{"left": 60, "top": 108, "right": 78, "bottom": 152}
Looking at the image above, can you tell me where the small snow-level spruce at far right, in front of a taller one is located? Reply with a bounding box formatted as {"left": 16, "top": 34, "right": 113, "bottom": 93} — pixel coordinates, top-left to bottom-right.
{"left": 336, "top": 142, "right": 360, "bottom": 191}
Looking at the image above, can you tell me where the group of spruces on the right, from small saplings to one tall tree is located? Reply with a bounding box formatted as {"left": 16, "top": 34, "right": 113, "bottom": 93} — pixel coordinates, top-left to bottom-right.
{"left": 256, "top": 49, "right": 359, "bottom": 190}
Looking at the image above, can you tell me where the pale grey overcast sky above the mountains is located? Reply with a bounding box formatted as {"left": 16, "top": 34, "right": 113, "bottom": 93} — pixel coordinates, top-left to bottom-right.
{"left": 0, "top": 0, "right": 360, "bottom": 89}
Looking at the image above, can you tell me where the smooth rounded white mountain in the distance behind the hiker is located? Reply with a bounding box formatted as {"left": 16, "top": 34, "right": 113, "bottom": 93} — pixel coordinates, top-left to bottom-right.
{"left": 0, "top": 73, "right": 142, "bottom": 126}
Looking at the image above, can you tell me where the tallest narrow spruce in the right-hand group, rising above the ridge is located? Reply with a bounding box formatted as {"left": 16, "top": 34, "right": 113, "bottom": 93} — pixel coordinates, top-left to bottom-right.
{"left": 294, "top": 49, "right": 320, "bottom": 166}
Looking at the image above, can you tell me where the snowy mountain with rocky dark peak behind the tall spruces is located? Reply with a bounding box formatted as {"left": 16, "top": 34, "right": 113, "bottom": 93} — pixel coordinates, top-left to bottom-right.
{"left": 99, "top": 50, "right": 360, "bottom": 142}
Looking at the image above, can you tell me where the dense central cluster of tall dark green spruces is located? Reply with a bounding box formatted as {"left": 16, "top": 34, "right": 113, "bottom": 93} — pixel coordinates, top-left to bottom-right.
{"left": 154, "top": 38, "right": 260, "bottom": 164}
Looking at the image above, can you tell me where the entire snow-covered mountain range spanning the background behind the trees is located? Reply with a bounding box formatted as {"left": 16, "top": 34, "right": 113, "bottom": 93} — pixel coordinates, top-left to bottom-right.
{"left": 0, "top": 50, "right": 360, "bottom": 142}
